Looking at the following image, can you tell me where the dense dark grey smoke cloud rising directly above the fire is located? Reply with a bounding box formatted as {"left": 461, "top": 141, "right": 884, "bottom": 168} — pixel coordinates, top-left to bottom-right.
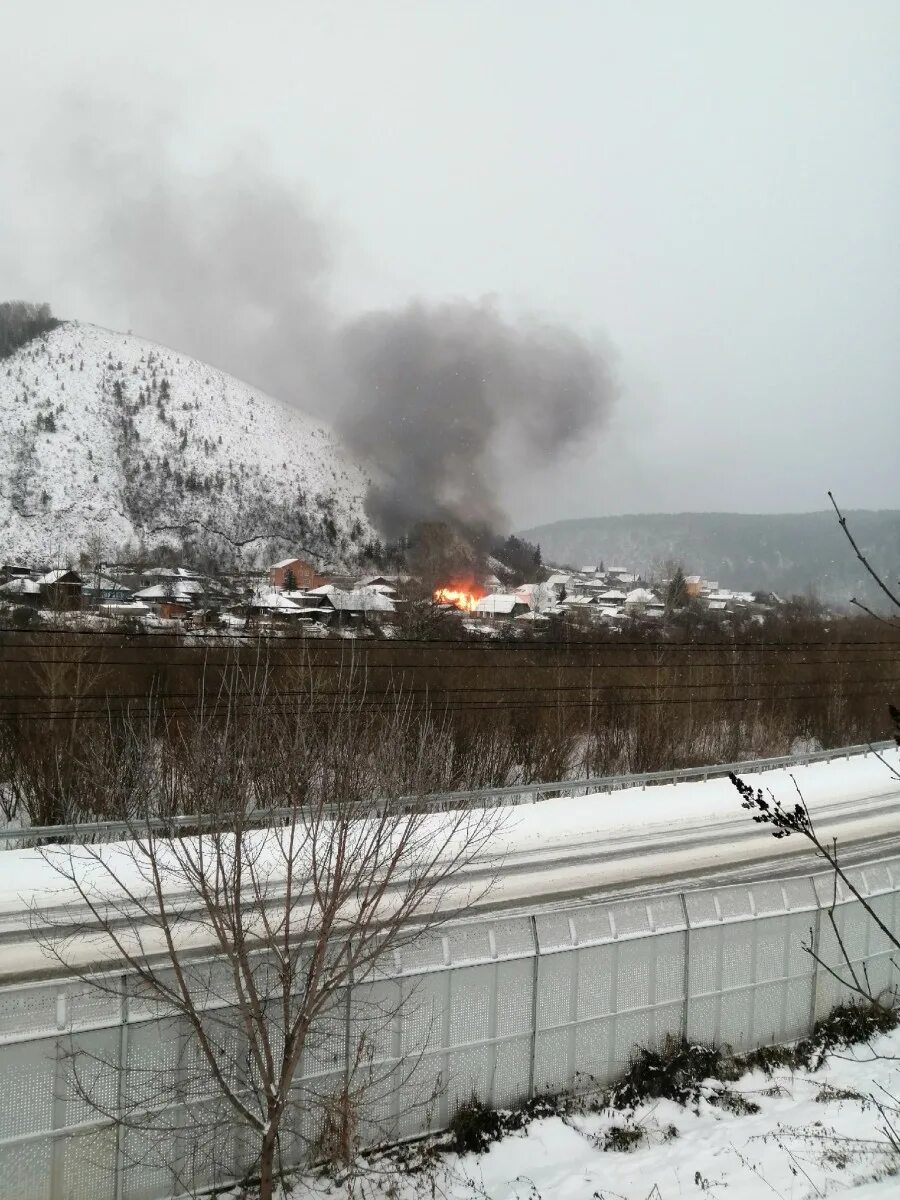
{"left": 340, "top": 302, "right": 613, "bottom": 536}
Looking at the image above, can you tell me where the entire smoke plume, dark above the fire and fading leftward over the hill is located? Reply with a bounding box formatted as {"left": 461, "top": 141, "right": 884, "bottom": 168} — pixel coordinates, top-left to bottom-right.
{"left": 0, "top": 102, "right": 614, "bottom": 536}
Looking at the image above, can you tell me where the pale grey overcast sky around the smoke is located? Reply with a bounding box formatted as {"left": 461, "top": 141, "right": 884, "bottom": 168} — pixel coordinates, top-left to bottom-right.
{"left": 0, "top": 0, "right": 900, "bottom": 526}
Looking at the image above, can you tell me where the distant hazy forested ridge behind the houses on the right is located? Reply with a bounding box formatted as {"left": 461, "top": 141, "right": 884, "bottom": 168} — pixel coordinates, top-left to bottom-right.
{"left": 520, "top": 509, "right": 900, "bottom": 604}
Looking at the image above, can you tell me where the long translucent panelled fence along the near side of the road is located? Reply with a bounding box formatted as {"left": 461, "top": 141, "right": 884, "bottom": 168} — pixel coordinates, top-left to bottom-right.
{"left": 0, "top": 859, "right": 900, "bottom": 1200}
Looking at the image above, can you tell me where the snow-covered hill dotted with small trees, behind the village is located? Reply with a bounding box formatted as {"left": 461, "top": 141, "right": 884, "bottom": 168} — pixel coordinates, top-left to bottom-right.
{"left": 0, "top": 322, "right": 372, "bottom": 563}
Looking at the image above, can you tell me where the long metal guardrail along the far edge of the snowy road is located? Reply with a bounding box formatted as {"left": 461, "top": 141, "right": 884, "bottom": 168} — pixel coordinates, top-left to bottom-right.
{"left": 0, "top": 739, "right": 894, "bottom": 850}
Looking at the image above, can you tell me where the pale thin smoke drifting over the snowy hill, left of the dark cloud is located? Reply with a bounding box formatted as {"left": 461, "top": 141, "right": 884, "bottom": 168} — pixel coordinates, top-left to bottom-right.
{"left": 9, "top": 96, "right": 336, "bottom": 416}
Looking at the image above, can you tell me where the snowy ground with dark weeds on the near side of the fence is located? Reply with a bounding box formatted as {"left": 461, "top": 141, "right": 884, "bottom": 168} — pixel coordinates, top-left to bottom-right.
{"left": 273, "top": 1031, "right": 900, "bottom": 1200}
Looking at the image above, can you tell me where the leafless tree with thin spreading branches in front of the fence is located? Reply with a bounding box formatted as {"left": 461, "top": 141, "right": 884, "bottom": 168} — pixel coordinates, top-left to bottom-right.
{"left": 34, "top": 668, "right": 499, "bottom": 1200}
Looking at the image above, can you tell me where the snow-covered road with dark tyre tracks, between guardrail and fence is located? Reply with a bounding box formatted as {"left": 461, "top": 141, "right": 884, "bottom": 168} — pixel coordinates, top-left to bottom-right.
{"left": 0, "top": 750, "right": 900, "bottom": 979}
